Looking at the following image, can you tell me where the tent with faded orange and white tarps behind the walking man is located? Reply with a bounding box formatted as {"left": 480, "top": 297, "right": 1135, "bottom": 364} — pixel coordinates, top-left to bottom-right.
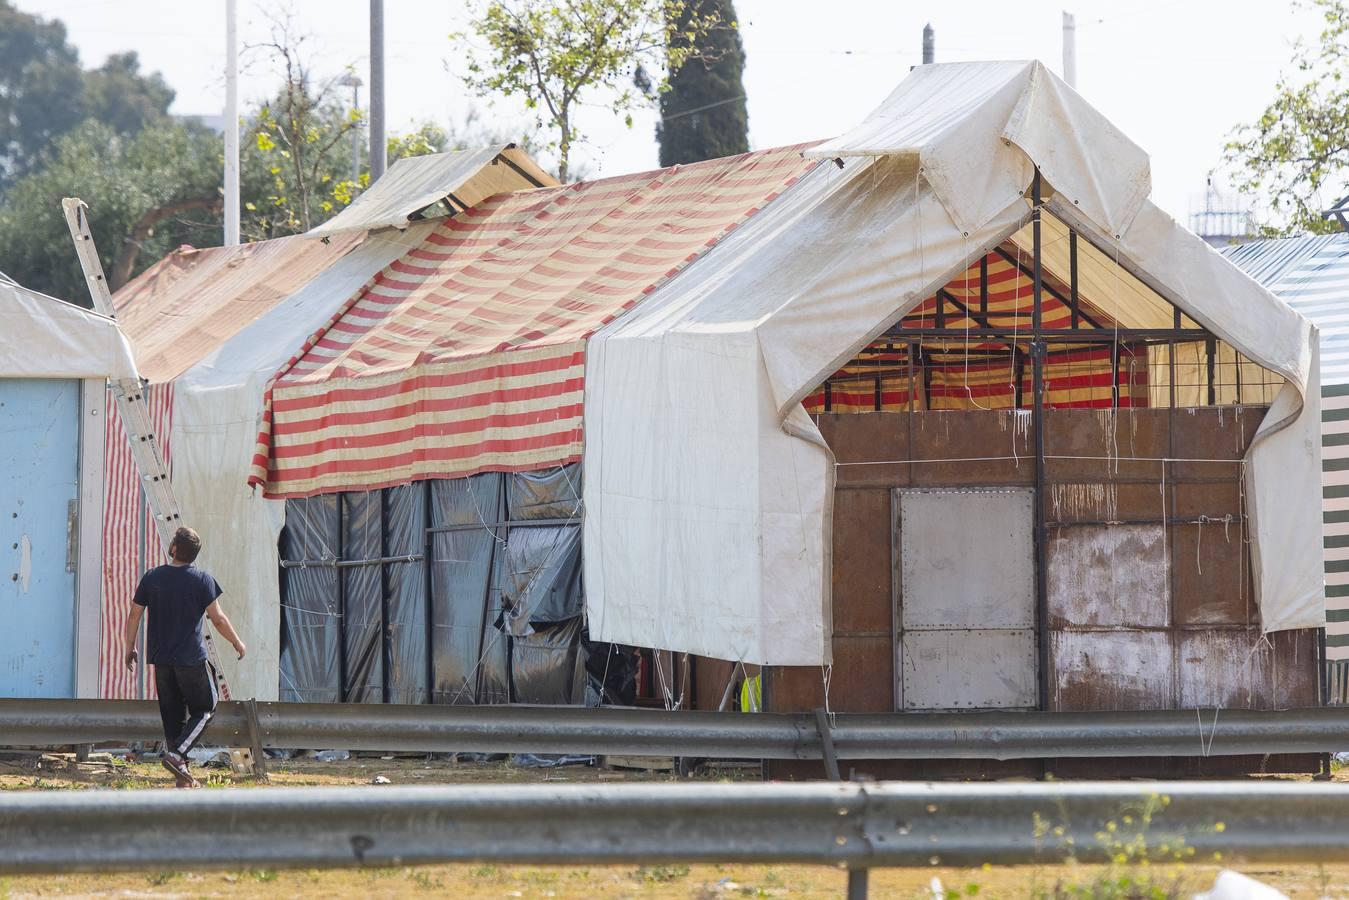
{"left": 94, "top": 146, "right": 552, "bottom": 700}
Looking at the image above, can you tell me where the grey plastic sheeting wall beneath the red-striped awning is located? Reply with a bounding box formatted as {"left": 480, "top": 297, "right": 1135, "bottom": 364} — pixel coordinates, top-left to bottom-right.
{"left": 282, "top": 466, "right": 590, "bottom": 704}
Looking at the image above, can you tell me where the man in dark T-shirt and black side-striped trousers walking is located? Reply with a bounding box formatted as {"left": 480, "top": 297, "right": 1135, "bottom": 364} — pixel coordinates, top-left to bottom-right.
{"left": 127, "top": 528, "right": 247, "bottom": 788}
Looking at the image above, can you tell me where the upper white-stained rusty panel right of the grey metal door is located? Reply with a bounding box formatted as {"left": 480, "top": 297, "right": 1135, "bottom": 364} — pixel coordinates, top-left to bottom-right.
{"left": 1047, "top": 525, "right": 1171, "bottom": 629}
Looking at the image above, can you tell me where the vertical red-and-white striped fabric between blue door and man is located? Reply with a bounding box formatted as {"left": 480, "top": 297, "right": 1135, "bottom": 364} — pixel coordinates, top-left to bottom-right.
{"left": 98, "top": 385, "right": 173, "bottom": 700}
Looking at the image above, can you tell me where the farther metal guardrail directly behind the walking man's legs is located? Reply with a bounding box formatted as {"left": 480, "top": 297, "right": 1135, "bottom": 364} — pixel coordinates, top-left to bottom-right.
{"left": 0, "top": 699, "right": 1349, "bottom": 760}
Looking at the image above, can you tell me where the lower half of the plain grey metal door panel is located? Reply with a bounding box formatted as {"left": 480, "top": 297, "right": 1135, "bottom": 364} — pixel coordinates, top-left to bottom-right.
{"left": 900, "top": 629, "right": 1037, "bottom": 710}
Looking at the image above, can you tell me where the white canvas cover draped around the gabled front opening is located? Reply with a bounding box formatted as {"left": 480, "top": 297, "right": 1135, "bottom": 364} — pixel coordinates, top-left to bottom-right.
{"left": 584, "top": 62, "right": 1325, "bottom": 665}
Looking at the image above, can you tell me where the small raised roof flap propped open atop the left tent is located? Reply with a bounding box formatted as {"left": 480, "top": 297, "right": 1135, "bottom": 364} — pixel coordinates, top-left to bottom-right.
{"left": 309, "top": 144, "right": 557, "bottom": 237}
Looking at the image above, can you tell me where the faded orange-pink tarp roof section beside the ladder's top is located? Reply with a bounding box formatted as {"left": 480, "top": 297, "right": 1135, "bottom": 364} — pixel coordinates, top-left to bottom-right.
{"left": 113, "top": 232, "right": 364, "bottom": 383}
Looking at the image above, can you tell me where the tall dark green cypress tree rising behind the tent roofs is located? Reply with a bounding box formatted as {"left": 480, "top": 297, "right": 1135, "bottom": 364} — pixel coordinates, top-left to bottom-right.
{"left": 656, "top": 0, "right": 750, "bottom": 166}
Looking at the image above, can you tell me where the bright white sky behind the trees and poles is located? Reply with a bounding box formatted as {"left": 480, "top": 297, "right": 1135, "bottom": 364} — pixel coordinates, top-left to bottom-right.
{"left": 15, "top": 0, "right": 1318, "bottom": 221}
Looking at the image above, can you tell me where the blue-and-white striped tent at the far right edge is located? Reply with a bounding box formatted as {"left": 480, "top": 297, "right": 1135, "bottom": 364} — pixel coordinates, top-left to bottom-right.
{"left": 1224, "top": 233, "right": 1349, "bottom": 703}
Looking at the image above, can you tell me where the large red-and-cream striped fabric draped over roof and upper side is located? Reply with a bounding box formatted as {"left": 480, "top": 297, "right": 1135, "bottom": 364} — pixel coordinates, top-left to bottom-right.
{"left": 250, "top": 146, "right": 812, "bottom": 497}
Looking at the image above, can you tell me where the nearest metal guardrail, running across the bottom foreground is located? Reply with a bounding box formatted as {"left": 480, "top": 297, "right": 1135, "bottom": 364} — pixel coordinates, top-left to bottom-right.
{"left": 0, "top": 781, "right": 1349, "bottom": 874}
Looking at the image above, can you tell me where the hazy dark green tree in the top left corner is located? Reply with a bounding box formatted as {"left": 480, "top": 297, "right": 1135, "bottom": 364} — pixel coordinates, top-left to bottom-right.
{"left": 0, "top": 0, "right": 173, "bottom": 189}
